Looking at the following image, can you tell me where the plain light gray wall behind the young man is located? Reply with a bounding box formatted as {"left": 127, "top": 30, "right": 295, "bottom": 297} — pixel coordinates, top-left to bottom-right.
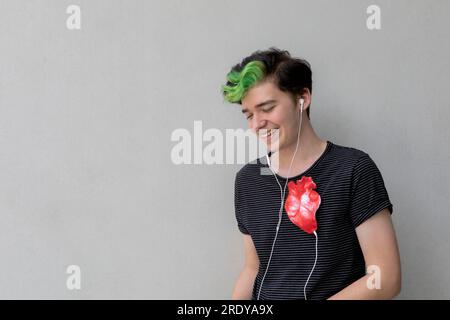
{"left": 0, "top": 0, "right": 450, "bottom": 299}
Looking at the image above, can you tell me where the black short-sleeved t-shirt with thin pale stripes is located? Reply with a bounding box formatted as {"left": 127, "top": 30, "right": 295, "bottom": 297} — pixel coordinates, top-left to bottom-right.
{"left": 235, "top": 141, "right": 393, "bottom": 300}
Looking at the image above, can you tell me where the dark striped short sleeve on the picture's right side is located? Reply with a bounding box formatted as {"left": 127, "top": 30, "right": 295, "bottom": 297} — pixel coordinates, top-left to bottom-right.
{"left": 350, "top": 153, "right": 393, "bottom": 228}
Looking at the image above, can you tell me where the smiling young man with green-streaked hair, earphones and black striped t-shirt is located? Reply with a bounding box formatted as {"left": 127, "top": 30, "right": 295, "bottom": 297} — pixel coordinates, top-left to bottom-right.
{"left": 222, "top": 48, "right": 401, "bottom": 300}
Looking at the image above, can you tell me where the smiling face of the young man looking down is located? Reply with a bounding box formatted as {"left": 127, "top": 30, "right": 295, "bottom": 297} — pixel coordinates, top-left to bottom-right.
{"left": 241, "top": 81, "right": 306, "bottom": 150}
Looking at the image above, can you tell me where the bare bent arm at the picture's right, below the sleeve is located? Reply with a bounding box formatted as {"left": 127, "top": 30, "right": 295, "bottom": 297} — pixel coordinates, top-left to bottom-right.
{"left": 329, "top": 209, "right": 401, "bottom": 300}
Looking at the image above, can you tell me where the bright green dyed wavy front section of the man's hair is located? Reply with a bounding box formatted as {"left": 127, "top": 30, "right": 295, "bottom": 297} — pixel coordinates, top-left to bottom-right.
{"left": 222, "top": 60, "right": 266, "bottom": 103}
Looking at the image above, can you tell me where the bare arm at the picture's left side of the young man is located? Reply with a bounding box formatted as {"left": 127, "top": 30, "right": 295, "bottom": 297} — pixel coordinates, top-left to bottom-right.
{"left": 231, "top": 234, "right": 259, "bottom": 300}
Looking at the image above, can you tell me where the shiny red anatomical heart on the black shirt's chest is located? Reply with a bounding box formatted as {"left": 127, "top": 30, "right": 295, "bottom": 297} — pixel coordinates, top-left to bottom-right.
{"left": 284, "top": 177, "right": 320, "bottom": 233}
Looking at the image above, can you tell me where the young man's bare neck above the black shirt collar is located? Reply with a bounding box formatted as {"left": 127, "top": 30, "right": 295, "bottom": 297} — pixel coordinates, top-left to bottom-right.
{"left": 271, "top": 117, "right": 327, "bottom": 177}
